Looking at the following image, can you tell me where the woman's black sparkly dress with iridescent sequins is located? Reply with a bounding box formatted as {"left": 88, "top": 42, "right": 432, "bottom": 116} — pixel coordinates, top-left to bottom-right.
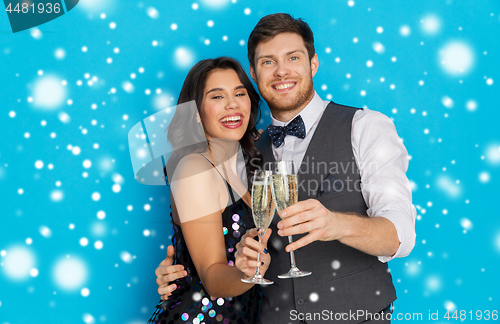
{"left": 148, "top": 170, "right": 261, "bottom": 324}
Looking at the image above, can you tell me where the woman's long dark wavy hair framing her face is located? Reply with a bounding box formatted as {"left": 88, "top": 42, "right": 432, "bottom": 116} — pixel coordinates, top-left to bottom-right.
{"left": 164, "top": 56, "right": 262, "bottom": 184}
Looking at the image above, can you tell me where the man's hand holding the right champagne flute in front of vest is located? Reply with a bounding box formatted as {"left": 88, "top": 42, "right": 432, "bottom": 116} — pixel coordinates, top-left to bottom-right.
{"left": 278, "top": 199, "right": 342, "bottom": 252}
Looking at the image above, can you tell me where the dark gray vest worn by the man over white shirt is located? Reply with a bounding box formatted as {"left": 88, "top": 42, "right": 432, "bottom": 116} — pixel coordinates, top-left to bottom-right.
{"left": 257, "top": 102, "right": 396, "bottom": 324}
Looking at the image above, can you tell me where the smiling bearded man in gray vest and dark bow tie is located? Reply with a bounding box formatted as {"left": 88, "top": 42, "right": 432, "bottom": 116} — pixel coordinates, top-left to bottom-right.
{"left": 156, "top": 14, "right": 416, "bottom": 324}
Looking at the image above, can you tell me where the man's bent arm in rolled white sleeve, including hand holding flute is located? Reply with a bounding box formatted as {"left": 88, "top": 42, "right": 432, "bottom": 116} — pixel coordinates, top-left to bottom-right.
{"left": 278, "top": 110, "right": 416, "bottom": 262}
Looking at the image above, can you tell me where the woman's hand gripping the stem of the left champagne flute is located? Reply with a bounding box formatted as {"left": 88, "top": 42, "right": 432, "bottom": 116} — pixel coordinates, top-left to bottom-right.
{"left": 234, "top": 228, "right": 272, "bottom": 278}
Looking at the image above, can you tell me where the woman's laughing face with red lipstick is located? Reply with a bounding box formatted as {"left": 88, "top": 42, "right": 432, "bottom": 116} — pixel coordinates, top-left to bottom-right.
{"left": 200, "top": 69, "right": 251, "bottom": 141}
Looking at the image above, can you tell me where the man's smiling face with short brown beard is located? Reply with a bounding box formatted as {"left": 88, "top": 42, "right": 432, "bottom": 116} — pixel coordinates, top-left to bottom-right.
{"left": 250, "top": 33, "right": 318, "bottom": 121}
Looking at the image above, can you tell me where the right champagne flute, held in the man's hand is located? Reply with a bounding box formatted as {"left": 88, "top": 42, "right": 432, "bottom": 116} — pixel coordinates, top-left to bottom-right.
{"left": 272, "top": 161, "right": 312, "bottom": 279}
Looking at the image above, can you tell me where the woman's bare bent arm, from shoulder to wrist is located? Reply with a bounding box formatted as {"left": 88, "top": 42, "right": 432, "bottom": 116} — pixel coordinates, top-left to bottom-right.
{"left": 172, "top": 157, "right": 270, "bottom": 297}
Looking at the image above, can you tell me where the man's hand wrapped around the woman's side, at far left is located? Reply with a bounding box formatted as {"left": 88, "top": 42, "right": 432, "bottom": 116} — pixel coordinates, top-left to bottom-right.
{"left": 155, "top": 245, "right": 187, "bottom": 300}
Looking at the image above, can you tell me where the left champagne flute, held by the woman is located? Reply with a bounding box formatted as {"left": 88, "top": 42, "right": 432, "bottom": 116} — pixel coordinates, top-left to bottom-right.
{"left": 241, "top": 171, "right": 275, "bottom": 285}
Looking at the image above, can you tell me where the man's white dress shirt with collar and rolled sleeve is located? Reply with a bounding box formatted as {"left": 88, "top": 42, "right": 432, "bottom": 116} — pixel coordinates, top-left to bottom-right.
{"left": 271, "top": 93, "right": 417, "bottom": 262}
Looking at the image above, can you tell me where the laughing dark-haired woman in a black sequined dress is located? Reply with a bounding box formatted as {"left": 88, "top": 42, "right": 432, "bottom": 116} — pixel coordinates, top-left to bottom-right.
{"left": 149, "top": 57, "right": 270, "bottom": 324}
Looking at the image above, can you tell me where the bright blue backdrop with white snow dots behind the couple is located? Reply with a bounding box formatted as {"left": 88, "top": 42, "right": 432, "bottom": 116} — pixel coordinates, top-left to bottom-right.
{"left": 0, "top": 0, "right": 500, "bottom": 324}
